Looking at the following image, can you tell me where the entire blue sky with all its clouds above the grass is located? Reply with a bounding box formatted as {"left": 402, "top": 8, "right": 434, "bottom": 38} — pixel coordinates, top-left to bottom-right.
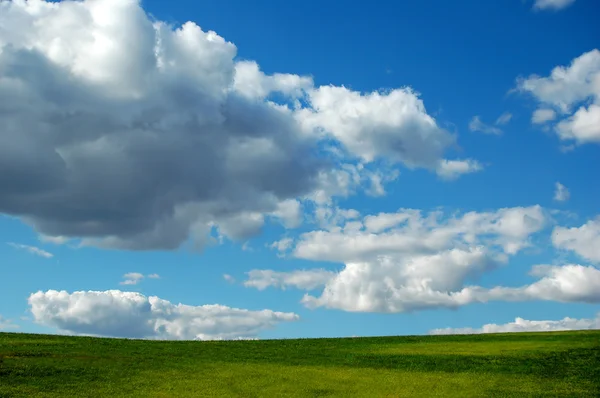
{"left": 0, "top": 0, "right": 600, "bottom": 340}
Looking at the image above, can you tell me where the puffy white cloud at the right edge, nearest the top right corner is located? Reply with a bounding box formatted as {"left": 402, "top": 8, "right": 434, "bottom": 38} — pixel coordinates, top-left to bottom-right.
{"left": 517, "top": 48, "right": 600, "bottom": 144}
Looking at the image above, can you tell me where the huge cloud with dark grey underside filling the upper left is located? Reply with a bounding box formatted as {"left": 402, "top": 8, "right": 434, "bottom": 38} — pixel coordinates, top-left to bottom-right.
{"left": 0, "top": 0, "right": 473, "bottom": 249}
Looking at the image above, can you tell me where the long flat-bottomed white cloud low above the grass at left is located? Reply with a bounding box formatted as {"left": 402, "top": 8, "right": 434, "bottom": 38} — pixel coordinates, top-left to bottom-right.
{"left": 28, "top": 290, "right": 299, "bottom": 340}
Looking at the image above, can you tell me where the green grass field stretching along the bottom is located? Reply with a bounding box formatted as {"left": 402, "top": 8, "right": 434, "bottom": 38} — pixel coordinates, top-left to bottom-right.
{"left": 0, "top": 331, "right": 600, "bottom": 397}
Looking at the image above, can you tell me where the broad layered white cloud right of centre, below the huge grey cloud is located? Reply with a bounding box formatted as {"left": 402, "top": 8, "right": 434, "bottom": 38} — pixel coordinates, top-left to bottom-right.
{"left": 291, "top": 206, "right": 548, "bottom": 312}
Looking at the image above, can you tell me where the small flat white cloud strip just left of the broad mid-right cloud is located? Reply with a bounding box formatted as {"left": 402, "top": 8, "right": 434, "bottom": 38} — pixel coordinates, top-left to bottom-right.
{"left": 244, "top": 269, "right": 335, "bottom": 290}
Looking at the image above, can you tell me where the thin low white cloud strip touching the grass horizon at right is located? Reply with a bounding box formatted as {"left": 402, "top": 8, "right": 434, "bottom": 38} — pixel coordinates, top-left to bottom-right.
{"left": 429, "top": 314, "right": 600, "bottom": 334}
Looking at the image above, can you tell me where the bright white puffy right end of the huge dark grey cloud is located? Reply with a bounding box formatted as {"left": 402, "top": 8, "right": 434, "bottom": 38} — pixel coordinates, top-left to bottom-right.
{"left": 297, "top": 86, "right": 476, "bottom": 170}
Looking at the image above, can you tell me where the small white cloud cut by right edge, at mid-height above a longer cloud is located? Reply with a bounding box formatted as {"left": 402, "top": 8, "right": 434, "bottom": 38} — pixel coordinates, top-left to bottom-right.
{"left": 552, "top": 217, "right": 600, "bottom": 263}
